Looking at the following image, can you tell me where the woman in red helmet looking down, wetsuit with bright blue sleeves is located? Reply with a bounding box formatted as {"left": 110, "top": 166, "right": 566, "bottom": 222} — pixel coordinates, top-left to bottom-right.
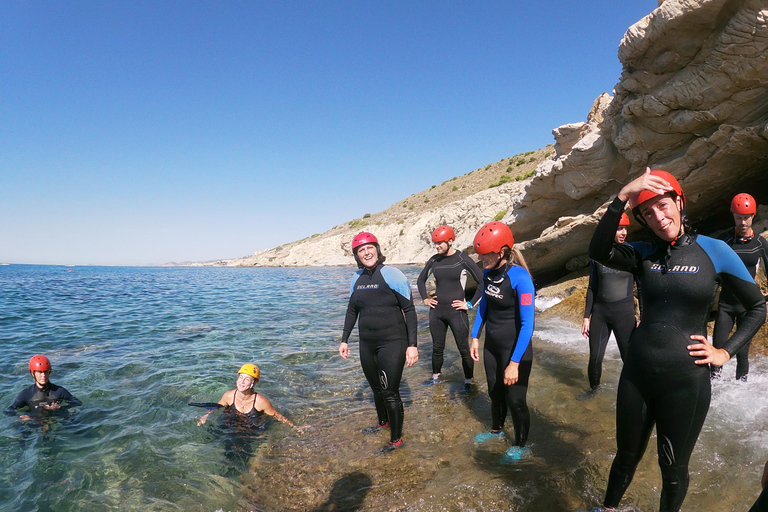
{"left": 469, "top": 222, "right": 535, "bottom": 458}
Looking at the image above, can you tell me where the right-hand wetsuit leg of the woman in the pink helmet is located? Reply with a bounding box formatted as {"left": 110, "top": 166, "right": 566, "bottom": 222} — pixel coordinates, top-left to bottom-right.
{"left": 375, "top": 339, "right": 408, "bottom": 442}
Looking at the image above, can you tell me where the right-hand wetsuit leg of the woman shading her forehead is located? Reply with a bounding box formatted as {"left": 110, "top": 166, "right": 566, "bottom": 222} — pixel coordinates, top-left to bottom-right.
{"left": 655, "top": 368, "right": 711, "bottom": 512}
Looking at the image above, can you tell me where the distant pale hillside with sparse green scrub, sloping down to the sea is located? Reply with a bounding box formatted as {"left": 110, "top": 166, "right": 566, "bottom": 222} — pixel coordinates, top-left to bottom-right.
{"left": 194, "top": 146, "right": 555, "bottom": 266}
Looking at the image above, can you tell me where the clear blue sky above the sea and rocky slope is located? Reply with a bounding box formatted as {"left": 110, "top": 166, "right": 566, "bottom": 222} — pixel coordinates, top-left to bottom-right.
{"left": 0, "top": 0, "right": 657, "bottom": 265}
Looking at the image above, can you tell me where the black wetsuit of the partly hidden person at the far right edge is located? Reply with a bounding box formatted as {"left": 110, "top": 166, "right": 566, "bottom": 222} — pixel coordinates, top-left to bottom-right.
{"left": 712, "top": 229, "right": 768, "bottom": 380}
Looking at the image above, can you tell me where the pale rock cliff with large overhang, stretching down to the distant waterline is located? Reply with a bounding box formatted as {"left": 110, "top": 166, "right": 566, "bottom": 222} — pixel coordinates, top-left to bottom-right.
{"left": 196, "top": 0, "right": 768, "bottom": 283}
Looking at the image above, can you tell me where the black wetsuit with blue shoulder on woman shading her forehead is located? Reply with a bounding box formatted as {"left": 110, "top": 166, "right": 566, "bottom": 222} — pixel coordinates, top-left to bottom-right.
{"left": 589, "top": 199, "right": 765, "bottom": 512}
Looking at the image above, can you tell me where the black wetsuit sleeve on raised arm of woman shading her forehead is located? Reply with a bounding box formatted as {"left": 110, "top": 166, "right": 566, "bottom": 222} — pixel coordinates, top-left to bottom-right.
{"left": 589, "top": 197, "right": 643, "bottom": 275}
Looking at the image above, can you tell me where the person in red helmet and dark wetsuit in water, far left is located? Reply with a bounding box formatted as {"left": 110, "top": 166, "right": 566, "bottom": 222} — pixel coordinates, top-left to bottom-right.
{"left": 6, "top": 354, "right": 82, "bottom": 421}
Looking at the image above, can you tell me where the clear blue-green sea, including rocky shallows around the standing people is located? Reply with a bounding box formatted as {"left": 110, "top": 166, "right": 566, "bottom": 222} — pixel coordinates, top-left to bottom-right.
{"left": 0, "top": 265, "right": 768, "bottom": 512}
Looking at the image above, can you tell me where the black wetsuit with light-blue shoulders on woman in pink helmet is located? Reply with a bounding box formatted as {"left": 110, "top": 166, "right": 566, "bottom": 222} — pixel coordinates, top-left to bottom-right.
{"left": 341, "top": 264, "right": 417, "bottom": 442}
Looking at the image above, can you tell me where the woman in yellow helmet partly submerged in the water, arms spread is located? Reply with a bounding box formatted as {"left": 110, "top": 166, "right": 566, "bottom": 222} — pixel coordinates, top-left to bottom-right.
{"left": 197, "top": 363, "right": 310, "bottom": 433}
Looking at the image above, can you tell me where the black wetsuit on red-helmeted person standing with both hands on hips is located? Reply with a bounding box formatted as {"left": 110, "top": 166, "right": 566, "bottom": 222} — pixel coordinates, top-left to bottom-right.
{"left": 416, "top": 251, "right": 483, "bottom": 379}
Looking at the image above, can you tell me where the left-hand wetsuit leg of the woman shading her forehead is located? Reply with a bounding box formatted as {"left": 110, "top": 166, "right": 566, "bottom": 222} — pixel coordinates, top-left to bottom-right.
{"left": 603, "top": 366, "right": 654, "bottom": 508}
